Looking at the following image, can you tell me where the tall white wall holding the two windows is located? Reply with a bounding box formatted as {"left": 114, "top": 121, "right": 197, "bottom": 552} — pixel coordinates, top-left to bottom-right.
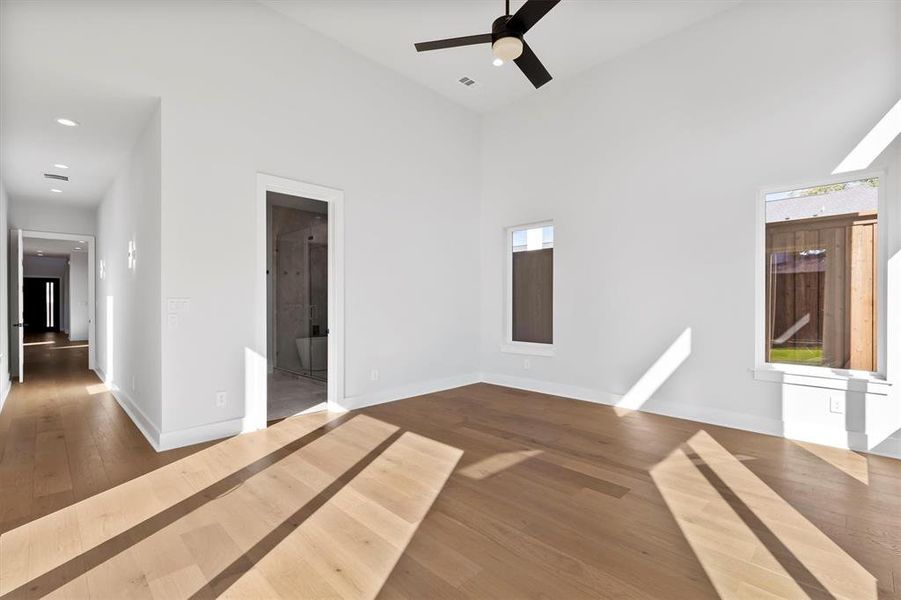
{"left": 481, "top": 2, "right": 901, "bottom": 454}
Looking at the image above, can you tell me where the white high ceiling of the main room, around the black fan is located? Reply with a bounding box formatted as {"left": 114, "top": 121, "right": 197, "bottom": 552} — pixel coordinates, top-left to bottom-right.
{"left": 260, "top": 0, "right": 740, "bottom": 112}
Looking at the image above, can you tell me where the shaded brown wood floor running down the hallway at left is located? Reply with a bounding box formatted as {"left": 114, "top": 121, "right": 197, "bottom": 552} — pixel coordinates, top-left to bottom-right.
{"left": 0, "top": 332, "right": 200, "bottom": 533}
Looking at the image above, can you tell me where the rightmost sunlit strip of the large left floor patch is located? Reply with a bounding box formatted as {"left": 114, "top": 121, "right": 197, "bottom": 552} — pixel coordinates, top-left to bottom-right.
{"left": 225, "top": 432, "right": 463, "bottom": 598}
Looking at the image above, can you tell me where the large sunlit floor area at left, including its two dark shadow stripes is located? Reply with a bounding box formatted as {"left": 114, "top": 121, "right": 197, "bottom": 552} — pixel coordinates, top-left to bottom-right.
{"left": 0, "top": 413, "right": 462, "bottom": 598}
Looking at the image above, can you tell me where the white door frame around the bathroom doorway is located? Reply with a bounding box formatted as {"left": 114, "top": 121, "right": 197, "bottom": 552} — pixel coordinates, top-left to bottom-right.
{"left": 243, "top": 173, "right": 344, "bottom": 431}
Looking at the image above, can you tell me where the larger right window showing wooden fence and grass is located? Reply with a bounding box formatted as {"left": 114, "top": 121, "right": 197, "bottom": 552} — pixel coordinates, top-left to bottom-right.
{"left": 764, "top": 177, "right": 879, "bottom": 371}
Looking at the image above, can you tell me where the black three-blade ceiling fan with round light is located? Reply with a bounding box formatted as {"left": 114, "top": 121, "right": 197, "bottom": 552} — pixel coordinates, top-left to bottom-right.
{"left": 414, "top": 0, "right": 560, "bottom": 88}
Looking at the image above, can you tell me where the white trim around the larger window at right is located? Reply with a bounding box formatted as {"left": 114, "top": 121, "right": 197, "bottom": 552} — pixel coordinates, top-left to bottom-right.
{"left": 752, "top": 171, "right": 894, "bottom": 394}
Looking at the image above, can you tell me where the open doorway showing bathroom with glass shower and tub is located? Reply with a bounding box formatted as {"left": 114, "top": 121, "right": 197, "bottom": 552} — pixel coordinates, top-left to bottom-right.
{"left": 266, "top": 191, "right": 329, "bottom": 421}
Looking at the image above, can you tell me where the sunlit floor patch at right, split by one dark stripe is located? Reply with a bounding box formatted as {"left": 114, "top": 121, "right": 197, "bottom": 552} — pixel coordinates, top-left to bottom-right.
{"left": 651, "top": 431, "right": 877, "bottom": 600}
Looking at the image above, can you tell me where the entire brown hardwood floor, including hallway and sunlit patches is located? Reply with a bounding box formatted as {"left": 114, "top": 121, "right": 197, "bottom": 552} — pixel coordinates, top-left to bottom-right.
{"left": 0, "top": 336, "right": 901, "bottom": 600}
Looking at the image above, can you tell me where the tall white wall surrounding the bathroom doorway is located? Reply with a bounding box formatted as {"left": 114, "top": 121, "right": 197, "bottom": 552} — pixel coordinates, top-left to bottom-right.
{"left": 150, "top": 3, "right": 479, "bottom": 432}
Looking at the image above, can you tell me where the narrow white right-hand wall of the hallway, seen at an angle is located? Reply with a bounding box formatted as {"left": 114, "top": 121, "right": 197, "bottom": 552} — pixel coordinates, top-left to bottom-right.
{"left": 96, "top": 103, "right": 162, "bottom": 443}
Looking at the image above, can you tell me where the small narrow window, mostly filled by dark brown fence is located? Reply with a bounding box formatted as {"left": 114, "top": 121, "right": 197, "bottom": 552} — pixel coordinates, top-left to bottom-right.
{"left": 507, "top": 223, "right": 554, "bottom": 346}
